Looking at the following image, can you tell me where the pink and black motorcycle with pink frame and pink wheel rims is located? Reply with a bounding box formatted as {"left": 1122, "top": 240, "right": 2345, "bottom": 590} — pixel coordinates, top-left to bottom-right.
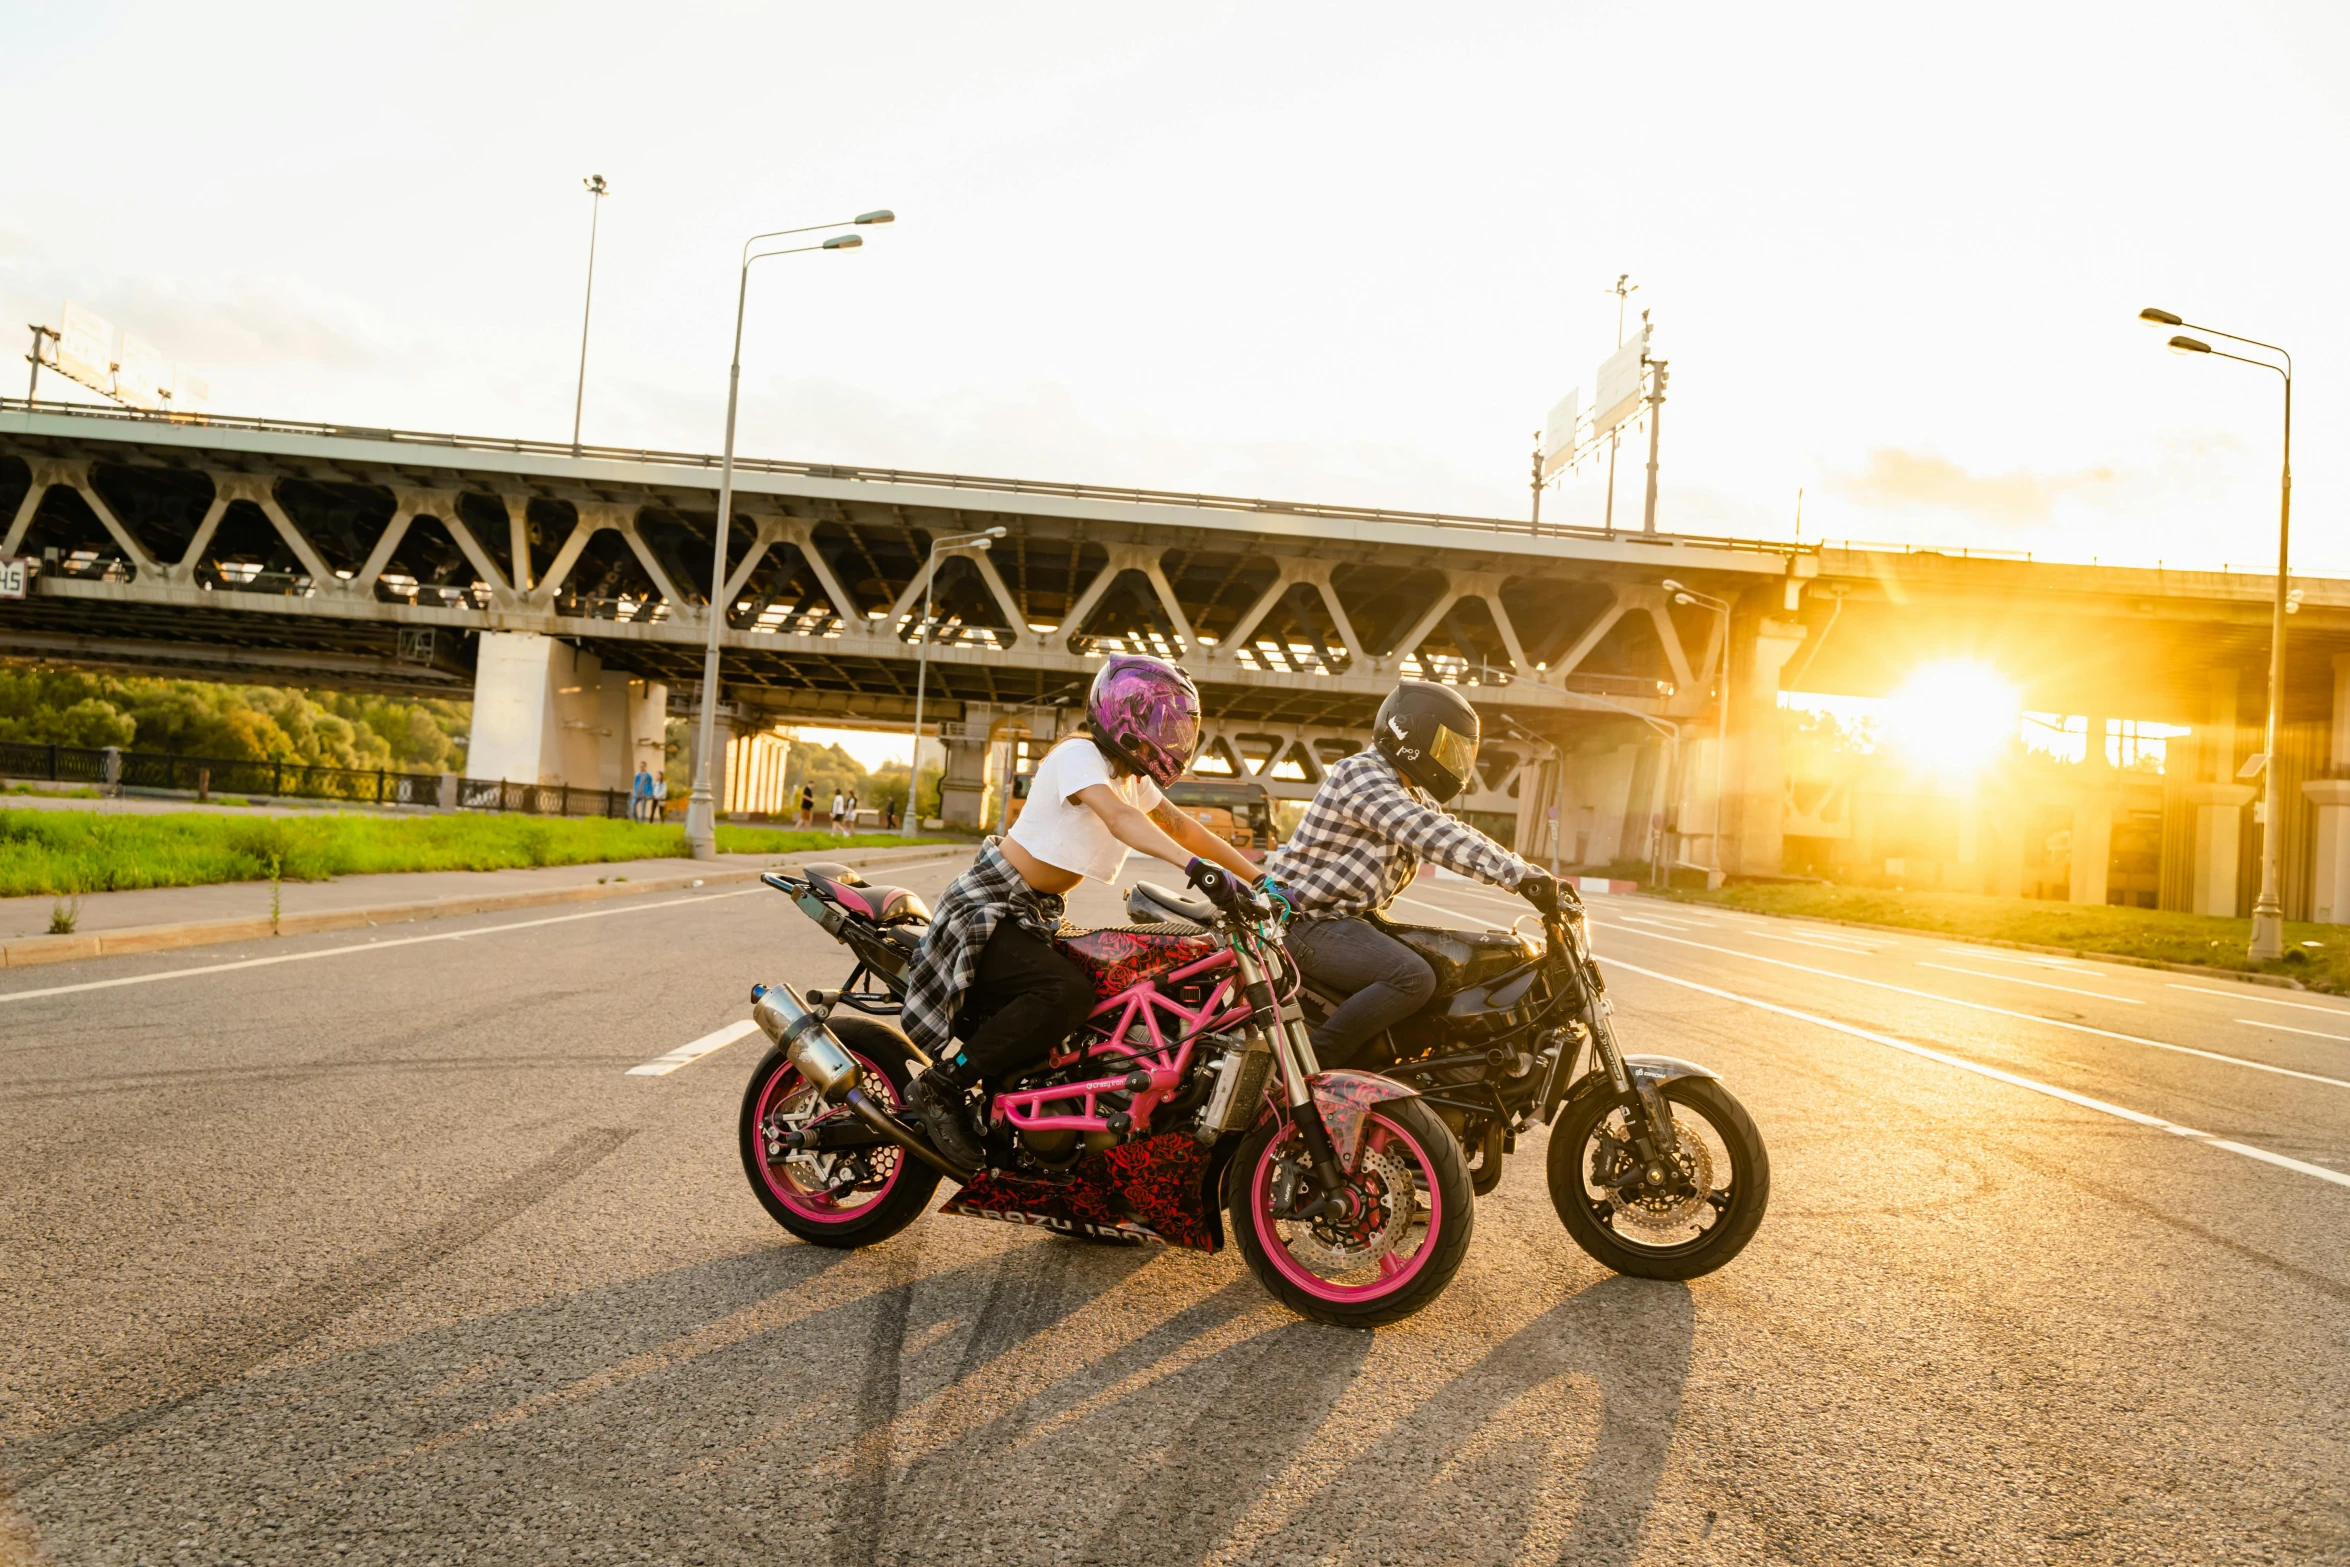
{"left": 743, "top": 865, "right": 1476, "bottom": 1327}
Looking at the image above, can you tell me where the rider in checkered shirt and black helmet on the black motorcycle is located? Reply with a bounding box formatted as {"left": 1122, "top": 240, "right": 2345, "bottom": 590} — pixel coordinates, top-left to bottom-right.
{"left": 1264, "top": 681, "right": 1560, "bottom": 1067}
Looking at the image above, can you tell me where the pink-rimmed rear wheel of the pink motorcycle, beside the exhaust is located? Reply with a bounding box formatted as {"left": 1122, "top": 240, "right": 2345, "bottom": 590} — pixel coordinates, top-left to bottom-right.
{"left": 740, "top": 1017, "right": 938, "bottom": 1247}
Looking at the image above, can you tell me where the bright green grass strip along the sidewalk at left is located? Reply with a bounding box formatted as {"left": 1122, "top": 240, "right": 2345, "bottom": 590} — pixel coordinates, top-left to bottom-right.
{"left": 0, "top": 811, "right": 954, "bottom": 897}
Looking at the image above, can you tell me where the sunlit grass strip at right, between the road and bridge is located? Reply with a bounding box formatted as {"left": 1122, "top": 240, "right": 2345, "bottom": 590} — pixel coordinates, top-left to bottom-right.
{"left": 1671, "top": 883, "right": 2350, "bottom": 994}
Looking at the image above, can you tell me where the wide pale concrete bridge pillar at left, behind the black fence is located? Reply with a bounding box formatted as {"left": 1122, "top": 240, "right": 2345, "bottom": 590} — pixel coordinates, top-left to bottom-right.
{"left": 465, "top": 632, "right": 667, "bottom": 789}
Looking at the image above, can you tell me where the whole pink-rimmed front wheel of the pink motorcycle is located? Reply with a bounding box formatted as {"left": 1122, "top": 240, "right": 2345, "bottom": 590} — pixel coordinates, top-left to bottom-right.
{"left": 1227, "top": 1099, "right": 1476, "bottom": 1327}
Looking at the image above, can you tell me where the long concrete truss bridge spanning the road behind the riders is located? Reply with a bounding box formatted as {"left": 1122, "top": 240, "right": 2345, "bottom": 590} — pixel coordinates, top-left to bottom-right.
{"left": 13, "top": 402, "right": 2350, "bottom": 919}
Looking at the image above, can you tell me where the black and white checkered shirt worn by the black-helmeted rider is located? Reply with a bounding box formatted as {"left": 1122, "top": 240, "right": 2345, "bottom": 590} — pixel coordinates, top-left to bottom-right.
{"left": 1264, "top": 747, "right": 1542, "bottom": 919}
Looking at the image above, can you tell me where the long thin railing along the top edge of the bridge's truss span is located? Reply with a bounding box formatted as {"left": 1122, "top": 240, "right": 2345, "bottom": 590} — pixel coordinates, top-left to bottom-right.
{"left": 0, "top": 397, "right": 1819, "bottom": 554}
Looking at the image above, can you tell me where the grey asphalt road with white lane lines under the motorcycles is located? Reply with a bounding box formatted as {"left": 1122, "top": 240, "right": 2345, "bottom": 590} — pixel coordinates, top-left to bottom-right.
{"left": 0, "top": 862, "right": 2350, "bottom": 1565}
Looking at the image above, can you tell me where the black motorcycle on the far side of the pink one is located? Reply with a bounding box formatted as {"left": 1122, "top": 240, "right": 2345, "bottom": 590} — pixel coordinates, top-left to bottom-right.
{"left": 1126, "top": 881, "right": 1770, "bottom": 1278}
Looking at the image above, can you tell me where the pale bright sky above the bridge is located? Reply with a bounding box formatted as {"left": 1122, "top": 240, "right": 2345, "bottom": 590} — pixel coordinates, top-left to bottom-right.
{"left": 0, "top": 0, "right": 2350, "bottom": 587}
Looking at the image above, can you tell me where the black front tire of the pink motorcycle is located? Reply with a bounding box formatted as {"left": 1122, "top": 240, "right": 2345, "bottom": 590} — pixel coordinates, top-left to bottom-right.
{"left": 1224, "top": 1099, "right": 1476, "bottom": 1327}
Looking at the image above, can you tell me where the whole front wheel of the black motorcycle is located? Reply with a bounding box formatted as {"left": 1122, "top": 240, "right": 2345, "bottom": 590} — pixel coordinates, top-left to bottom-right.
{"left": 1549, "top": 1078, "right": 1770, "bottom": 1278}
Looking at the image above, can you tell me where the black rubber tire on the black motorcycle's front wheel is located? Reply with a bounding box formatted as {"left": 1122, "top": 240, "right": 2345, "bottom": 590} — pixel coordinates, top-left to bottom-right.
{"left": 1549, "top": 1078, "right": 1770, "bottom": 1278}
